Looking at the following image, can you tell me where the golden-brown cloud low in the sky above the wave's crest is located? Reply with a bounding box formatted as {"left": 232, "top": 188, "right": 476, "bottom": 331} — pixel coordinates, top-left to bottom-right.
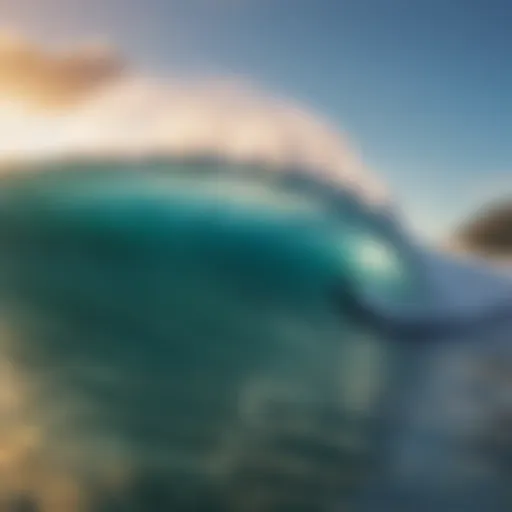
{"left": 0, "top": 33, "right": 124, "bottom": 108}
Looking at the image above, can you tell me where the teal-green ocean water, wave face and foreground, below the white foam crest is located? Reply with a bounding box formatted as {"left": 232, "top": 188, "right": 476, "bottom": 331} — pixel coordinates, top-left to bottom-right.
{"left": 0, "top": 160, "right": 512, "bottom": 512}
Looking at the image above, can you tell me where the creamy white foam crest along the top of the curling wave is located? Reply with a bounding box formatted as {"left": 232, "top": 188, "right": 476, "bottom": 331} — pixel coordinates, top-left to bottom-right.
{"left": 0, "top": 75, "right": 388, "bottom": 205}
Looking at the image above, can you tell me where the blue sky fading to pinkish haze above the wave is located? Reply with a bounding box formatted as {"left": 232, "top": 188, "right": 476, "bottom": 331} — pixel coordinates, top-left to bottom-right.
{"left": 0, "top": 0, "right": 512, "bottom": 240}
